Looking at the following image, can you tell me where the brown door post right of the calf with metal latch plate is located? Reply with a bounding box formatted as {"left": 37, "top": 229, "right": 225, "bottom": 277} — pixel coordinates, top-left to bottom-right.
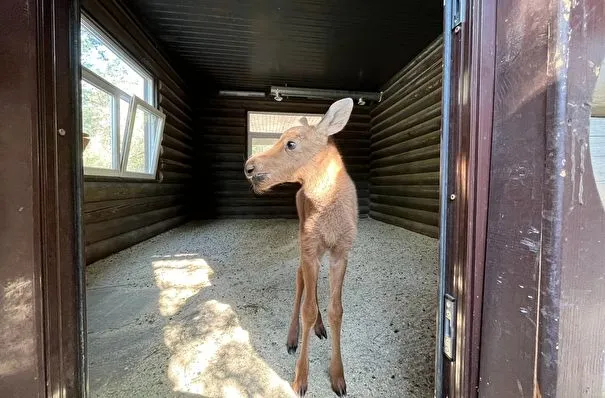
{"left": 435, "top": 0, "right": 496, "bottom": 398}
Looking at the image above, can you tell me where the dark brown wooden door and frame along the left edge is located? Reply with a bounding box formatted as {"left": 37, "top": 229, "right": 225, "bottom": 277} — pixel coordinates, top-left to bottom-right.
{"left": 0, "top": 0, "right": 85, "bottom": 398}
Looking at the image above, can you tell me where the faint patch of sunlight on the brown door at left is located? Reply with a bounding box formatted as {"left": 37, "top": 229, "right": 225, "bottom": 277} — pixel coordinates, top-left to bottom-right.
{"left": 0, "top": 278, "right": 35, "bottom": 379}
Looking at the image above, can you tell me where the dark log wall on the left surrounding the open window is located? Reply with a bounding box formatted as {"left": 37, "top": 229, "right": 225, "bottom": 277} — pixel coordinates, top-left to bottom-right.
{"left": 81, "top": 0, "right": 193, "bottom": 263}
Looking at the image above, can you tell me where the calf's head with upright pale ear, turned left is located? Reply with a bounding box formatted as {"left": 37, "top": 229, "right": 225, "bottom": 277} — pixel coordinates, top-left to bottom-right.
{"left": 244, "top": 98, "right": 353, "bottom": 193}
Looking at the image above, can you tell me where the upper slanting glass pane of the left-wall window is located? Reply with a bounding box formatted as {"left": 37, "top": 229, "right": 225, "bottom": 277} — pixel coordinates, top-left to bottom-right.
{"left": 81, "top": 24, "right": 151, "bottom": 103}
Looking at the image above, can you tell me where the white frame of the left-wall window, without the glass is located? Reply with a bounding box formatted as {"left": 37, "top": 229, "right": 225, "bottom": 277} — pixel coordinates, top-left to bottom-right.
{"left": 80, "top": 12, "right": 166, "bottom": 180}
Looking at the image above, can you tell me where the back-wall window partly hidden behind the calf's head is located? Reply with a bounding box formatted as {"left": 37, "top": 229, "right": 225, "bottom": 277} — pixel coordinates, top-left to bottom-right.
{"left": 248, "top": 112, "right": 323, "bottom": 156}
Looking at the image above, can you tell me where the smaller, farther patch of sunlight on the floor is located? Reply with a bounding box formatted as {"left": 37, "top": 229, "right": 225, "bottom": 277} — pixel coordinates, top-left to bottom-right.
{"left": 153, "top": 256, "right": 213, "bottom": 316}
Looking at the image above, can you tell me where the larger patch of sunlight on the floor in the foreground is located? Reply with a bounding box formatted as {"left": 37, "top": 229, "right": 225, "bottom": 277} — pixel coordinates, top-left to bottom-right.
{"left": 164, "top": 300, "right": 295, "bottom": 398}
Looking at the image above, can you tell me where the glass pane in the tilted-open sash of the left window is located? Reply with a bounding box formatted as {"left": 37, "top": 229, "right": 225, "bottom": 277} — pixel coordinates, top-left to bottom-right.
{"left": 126, "top": 106, "right": 159, "bottom": 174}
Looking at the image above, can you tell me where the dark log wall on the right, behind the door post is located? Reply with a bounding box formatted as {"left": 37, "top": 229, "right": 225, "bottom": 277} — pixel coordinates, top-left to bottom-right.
{"left": 370, "top": 37, "right": 443, "bottom": 237}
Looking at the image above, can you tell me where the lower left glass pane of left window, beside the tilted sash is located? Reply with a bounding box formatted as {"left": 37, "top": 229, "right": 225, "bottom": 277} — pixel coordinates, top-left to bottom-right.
{"left": 82, "top": 81, "right": 113, "bottom": 169}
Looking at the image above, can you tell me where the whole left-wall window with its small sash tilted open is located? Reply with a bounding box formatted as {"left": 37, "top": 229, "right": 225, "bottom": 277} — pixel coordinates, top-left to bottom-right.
{"left": 80, "top": 16, "right": 165, "bottom": 178}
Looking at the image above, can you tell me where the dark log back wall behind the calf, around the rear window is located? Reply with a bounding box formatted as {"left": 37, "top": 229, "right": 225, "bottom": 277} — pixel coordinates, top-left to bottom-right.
{"left": 195, "top": 97, "right": 370, "bottom": 218}
